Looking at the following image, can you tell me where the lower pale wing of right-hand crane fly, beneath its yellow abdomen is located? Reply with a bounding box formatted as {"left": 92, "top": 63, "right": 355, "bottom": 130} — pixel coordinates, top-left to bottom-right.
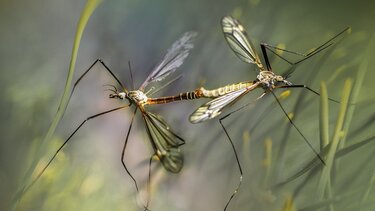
{"left": 189, "top": 83, "right": 259, "bottom": 124}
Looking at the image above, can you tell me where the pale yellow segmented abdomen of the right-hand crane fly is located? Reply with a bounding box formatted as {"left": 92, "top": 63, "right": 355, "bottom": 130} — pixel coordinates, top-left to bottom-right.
{"left": 197, "top": 81, "right": 254, "bottom": 98}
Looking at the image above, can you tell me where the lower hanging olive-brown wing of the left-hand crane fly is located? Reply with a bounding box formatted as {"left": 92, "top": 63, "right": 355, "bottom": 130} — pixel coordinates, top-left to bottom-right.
{"left": 142, "top": 112, "right": 185, "bottom": 173}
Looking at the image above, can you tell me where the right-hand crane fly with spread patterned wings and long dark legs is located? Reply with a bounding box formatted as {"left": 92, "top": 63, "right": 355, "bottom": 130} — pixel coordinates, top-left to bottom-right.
{"left": 189, "top": 16, "right": 350, "bottom": 210}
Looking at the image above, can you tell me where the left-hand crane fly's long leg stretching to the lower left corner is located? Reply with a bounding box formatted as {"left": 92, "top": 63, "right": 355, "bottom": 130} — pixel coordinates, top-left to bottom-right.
{"left": 24, "top": 105, "right": 129, "bottom": 192}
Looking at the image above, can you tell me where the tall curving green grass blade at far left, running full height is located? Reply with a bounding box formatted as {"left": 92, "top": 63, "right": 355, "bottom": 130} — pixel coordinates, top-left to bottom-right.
{"left": 12, "top": 0, "right": 102, "bottom": 210}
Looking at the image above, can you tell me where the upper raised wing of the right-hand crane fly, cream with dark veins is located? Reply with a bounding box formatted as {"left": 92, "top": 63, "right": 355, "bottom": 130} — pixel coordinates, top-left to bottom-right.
{"left": 221, "top": 16, "right": 263, "bottom": 68}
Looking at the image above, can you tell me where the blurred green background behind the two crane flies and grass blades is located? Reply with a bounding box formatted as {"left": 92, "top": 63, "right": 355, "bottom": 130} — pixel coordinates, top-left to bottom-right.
{"left": 0, "top": 0, "right": 375, "bottom": 210}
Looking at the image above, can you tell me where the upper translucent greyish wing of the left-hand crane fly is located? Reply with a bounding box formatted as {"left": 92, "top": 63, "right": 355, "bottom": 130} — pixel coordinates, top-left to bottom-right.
{"left": 139, "top": 32, "right": 197, "bottom": 90}
